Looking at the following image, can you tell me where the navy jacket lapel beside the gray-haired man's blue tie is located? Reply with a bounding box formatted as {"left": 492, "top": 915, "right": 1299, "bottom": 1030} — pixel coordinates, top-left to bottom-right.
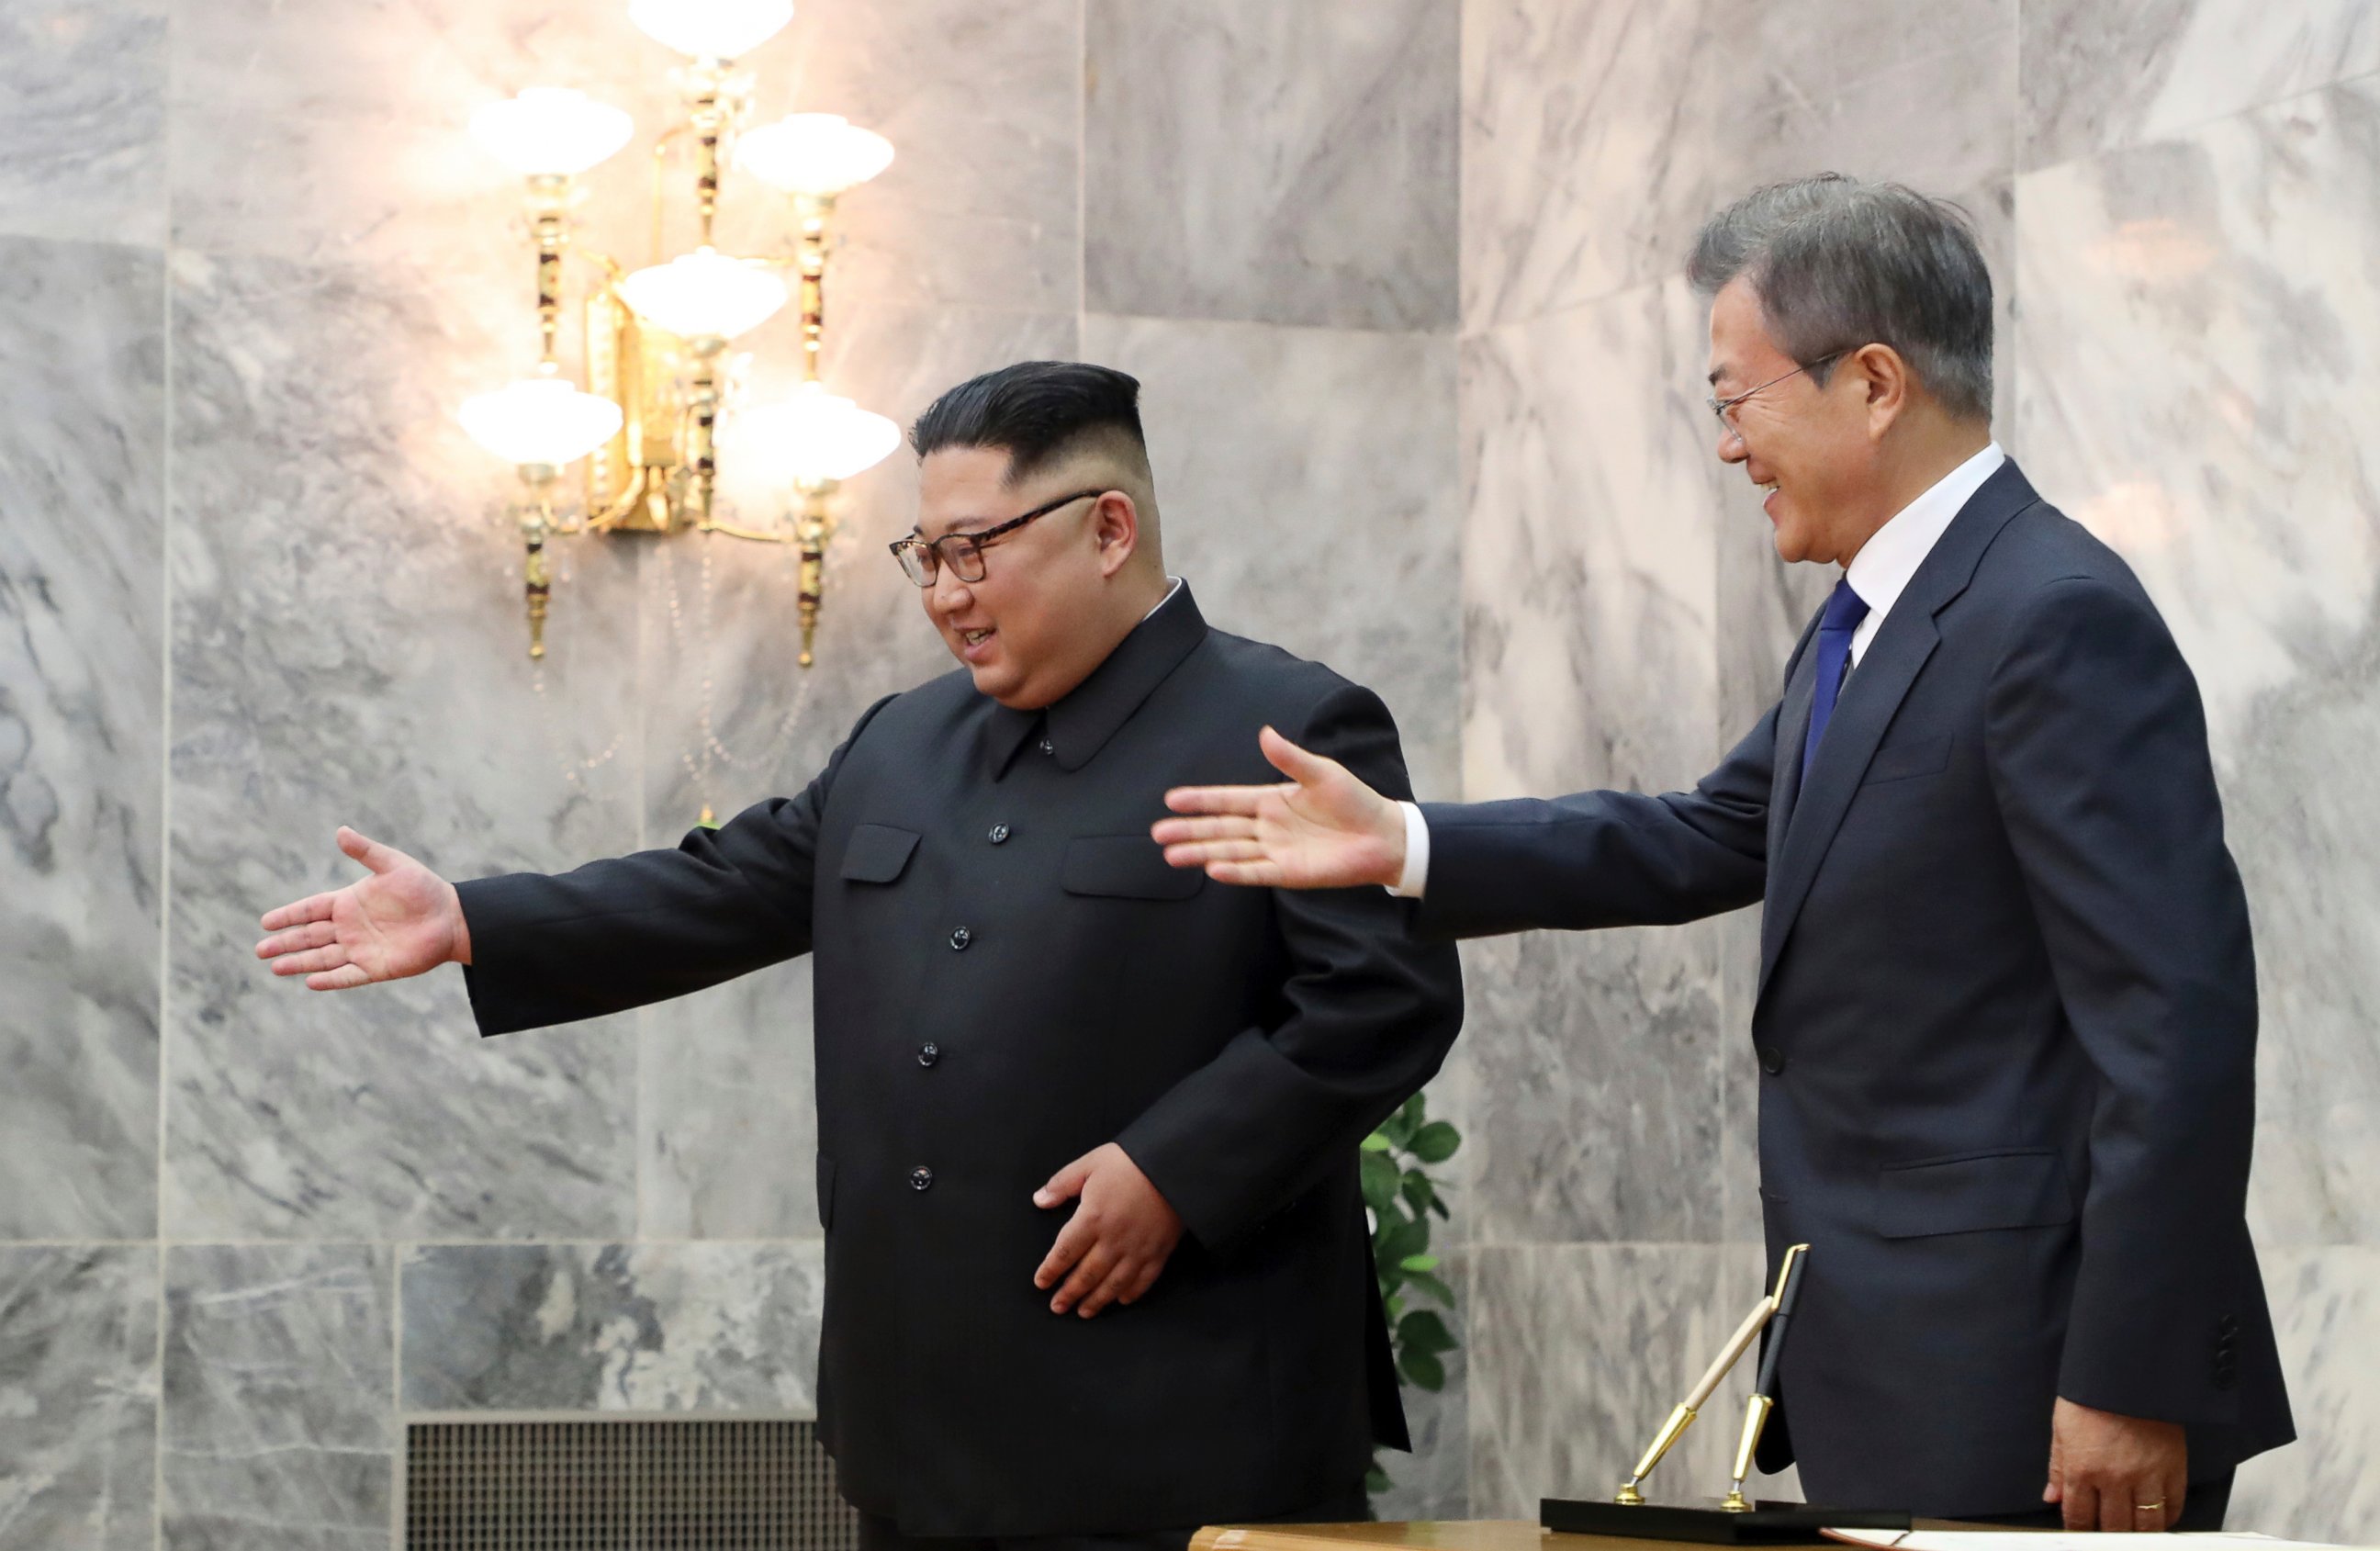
{"left": 1761, "top": 459, "right": 2039, "bottom": 992}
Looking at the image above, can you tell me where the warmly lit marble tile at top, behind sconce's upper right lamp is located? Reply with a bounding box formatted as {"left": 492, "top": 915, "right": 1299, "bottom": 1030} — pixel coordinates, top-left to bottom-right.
{"left": 709, "top": 0, "right": 1083, "bottom": 319}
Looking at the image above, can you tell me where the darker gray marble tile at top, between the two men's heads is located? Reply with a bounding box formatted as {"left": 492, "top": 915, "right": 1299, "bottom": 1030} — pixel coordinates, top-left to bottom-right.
{"left": 1083, "top": 0, "right": 1459, "bottom": 328}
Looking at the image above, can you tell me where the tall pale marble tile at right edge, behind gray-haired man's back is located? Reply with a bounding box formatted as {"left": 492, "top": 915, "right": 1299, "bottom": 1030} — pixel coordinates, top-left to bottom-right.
{"left": 2014, "top": 84, "right": 2380, "bottom": 1244}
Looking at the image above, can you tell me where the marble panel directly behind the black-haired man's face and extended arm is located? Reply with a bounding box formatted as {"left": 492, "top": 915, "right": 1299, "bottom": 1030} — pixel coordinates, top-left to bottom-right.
{"left": 638, "top": 302, "right": 1076, "bottom": 1240}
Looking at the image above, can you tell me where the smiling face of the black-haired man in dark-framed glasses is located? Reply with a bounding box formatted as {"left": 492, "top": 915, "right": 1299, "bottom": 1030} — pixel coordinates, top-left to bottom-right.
{"left": 916, "top": 447, "right": 1163, "bottom": 712}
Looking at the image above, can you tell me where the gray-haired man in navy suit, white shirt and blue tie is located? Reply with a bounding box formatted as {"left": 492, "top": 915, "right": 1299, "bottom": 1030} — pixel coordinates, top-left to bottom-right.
{"left": 1157, "top": 178, "right": 2292, "bottom": 1530}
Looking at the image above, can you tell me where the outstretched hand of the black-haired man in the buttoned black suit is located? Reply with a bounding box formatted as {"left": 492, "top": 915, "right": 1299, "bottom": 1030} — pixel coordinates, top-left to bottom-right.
{"left": 257, "top": 826, "right": 471, "bottom": 992}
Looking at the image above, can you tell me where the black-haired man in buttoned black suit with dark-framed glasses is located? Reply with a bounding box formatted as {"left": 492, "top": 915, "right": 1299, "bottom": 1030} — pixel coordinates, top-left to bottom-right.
{"left": 260, "top": 362, "right": 1461, "bottom": 1548}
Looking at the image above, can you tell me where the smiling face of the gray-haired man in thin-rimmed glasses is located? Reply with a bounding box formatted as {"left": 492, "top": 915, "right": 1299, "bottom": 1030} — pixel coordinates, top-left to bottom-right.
{"left": 1712, "top": 278, "right": 1897, "bottom": 564}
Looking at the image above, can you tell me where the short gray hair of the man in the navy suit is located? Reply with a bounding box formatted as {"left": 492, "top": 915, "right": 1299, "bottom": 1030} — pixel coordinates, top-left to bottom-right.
{"left": 1685, "top": 172, "right": 1993, "bottom": 421}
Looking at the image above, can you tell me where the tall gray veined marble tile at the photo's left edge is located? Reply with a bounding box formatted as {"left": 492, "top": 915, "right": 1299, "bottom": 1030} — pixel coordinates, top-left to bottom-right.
{"left": 0, "top": 238, "right": 164, "bottom": 1240}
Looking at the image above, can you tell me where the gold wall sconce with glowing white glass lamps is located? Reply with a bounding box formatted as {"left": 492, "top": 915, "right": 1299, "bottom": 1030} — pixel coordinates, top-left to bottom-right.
{"left": 462, "top": 0, "right": 900, "bottom": 669}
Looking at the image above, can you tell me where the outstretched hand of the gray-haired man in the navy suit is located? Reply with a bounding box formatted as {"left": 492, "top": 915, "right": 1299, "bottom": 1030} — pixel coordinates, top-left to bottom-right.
{"left": 1150, "top": 728, "right": 1404, "bottom": 890}
